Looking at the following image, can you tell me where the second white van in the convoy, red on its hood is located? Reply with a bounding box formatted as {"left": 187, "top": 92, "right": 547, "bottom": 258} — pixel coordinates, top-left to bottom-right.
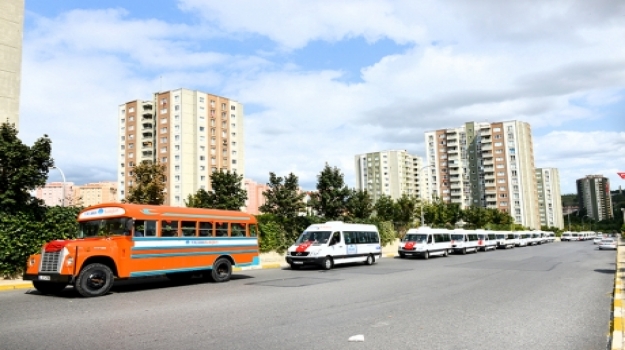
{"left": 397, "top": 227, "right": 451, "bottom": 259}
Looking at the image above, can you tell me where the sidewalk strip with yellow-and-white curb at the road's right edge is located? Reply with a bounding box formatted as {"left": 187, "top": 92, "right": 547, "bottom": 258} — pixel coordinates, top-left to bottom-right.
{"left": 610, "top": 238, "right": 625, "bottom": 350}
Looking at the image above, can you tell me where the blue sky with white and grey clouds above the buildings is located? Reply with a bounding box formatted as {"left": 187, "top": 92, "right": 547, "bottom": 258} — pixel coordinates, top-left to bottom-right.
{"left": 20, "top": 0, "right": 625, "bottom": 193}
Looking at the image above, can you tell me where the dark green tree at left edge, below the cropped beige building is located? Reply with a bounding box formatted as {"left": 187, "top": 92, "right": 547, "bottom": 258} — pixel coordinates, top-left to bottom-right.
{"left": 0, "top": 123, "right": 54, "bottom": 214}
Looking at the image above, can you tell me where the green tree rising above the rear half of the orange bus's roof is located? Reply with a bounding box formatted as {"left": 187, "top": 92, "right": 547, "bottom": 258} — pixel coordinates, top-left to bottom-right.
{"left": 208, "top": 170, "right": 247, "bottom": 210}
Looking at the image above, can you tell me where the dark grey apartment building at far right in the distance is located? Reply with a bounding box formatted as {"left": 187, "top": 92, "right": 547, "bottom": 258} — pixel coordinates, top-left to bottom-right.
{"left": 576, "top": 175, "right": 614, "bottom": 221}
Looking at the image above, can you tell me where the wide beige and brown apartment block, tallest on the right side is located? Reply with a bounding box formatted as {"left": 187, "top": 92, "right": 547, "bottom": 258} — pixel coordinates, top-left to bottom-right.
{"left": 425, "top": 121, "right": 540, "bottom": 229}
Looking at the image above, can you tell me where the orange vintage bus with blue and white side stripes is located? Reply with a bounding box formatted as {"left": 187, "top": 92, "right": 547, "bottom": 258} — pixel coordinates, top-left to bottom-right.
{"left": 24, "top": 203, "right": 259, "bottom": 297}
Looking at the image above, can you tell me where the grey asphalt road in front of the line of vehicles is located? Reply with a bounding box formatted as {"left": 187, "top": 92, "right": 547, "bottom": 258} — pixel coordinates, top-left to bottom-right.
{"left": 0, "top": 241, "right": 615, "bottom": 350}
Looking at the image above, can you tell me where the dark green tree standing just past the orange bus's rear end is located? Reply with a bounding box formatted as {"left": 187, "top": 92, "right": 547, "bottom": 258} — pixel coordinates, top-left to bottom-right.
{"left": 259, "top": 172, "right": 306, "bottom": 218}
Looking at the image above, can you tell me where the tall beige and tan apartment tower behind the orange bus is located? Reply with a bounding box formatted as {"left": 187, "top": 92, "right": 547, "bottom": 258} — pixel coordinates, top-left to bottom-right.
{"left": 117, "top": 89, "right": 245, "bottom": 206}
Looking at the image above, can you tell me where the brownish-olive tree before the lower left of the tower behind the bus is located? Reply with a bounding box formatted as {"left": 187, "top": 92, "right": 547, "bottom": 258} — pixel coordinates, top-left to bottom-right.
{"left": 126, "top": 161, "right": 166, "bottom": 205}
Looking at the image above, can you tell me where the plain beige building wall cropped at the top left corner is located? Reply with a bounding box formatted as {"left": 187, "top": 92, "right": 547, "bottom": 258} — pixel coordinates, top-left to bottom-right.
{"left": 0, "top": 0, "right": 24, "bottom": 128}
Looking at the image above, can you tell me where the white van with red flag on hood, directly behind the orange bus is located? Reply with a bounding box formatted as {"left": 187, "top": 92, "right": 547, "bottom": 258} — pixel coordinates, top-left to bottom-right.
{"left": 286, "top": 221, "right": 382, "bottom": 270}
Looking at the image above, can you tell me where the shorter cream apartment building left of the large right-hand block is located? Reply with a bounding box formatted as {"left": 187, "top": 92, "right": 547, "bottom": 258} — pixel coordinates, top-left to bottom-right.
{"left": 355, "top": 150, "right": 427, "bottom": 201}
